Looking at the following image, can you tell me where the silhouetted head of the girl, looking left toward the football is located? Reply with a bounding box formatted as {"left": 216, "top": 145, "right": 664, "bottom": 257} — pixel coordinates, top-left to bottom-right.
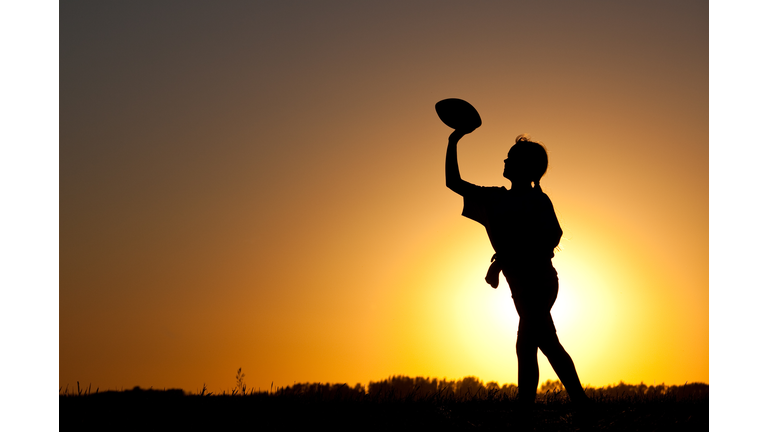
{"left": 504, "top": 135, "right": 549, "bottom": 191}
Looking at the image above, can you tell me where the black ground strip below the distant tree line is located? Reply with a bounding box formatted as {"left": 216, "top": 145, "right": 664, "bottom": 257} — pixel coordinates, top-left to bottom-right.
{"left": 59, "top": 390, "right": 709, "bottom": 431}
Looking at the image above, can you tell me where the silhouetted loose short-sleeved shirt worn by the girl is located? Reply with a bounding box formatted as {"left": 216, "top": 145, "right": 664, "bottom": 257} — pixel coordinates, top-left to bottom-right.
{"left": 461, "top": 185, "right": 563, "bottom": 269}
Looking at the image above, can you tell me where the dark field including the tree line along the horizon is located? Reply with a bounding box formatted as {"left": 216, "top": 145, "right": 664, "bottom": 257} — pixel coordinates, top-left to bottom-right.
{"left": 59, "top": 377, "right": 709, "bottom": 431}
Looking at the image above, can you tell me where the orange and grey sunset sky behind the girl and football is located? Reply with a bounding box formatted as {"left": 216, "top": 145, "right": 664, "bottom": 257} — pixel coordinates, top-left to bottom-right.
{"left": 59, "top": 1, "right": 709, "bottom": 391}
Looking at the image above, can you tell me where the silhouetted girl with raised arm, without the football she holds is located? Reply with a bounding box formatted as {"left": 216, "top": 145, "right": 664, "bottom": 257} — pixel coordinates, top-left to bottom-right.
{"left": 445, "top": 131, "right": 587, "bottom": 403}
